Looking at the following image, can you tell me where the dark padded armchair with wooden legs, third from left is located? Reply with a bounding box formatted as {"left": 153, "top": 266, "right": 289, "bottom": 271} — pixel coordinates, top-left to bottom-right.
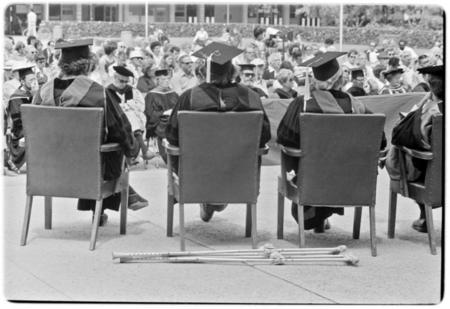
{"left": 277, "top": 113, "right": 385, "bottom": 256}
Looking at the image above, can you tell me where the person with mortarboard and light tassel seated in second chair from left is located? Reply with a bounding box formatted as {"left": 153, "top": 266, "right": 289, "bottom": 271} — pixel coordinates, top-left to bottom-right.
{"left": 166, "top": 42, "right": 270, "bottom": 222}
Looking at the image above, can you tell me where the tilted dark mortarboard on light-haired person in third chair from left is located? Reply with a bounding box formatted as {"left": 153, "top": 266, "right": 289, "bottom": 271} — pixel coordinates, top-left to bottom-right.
{"left": 300, "top": 52, "right": 346, "bottom": 81}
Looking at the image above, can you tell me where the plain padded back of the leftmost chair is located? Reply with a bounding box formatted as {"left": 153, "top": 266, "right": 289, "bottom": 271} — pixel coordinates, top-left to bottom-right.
{"left": 21, "top": 104, "right": 103, "bottom": 200}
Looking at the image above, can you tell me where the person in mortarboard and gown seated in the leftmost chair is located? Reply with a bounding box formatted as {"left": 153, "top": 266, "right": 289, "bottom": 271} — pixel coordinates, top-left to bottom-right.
{"left": 33, "top": 39, "right": 148, "bottom": 225}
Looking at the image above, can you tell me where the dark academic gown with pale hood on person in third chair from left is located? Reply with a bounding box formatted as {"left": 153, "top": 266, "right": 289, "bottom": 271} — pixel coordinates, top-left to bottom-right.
{"left": 277, "top": 90, "right": 386, "bottom": 229}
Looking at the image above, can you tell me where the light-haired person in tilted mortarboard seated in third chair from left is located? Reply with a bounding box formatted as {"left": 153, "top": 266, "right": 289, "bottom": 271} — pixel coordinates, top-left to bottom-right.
{"left": 277, "top": 52, "right": 386, "bottom": 232}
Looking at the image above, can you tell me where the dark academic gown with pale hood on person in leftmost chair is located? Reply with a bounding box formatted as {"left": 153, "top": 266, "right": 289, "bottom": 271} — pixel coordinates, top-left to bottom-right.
{"left": 33, "top": 76, "right": 139, "bottom": 211}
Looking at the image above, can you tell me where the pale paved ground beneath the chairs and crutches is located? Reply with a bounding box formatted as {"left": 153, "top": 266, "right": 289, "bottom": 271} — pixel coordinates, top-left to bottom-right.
{"left": 0, "top": 166, "right": 442, "bottom": 304}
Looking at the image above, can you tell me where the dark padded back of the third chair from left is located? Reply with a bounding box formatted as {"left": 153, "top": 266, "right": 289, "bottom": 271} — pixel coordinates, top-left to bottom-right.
{"left": 297, "top": 113, "right": 385, "bottom": 206}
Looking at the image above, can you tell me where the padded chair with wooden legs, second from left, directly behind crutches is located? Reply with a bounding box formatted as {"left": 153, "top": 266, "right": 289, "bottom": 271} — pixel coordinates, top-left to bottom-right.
{"left": 164, "top": 111, "right": 268, "bottom": 251}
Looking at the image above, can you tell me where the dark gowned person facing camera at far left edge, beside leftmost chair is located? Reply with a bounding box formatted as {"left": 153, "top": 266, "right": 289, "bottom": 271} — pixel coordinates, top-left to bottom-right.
{"left": 5, "top": 86, "right": 33, "bottom": 169}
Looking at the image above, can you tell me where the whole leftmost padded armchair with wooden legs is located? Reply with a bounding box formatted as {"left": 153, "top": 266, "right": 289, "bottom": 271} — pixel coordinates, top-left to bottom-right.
{"left": 20, "top": 104, "right": 128, "bottom": 250}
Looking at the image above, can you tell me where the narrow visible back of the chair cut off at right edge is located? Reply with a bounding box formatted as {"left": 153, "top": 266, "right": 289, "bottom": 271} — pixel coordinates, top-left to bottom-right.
{"left": 425, "top": 115, "right": 443, "bottom": 207}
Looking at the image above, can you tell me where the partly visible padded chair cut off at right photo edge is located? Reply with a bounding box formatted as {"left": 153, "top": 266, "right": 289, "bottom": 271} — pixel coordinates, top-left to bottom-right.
{"left": 388, "top": 115, "right": 443, "bottom": 255}
